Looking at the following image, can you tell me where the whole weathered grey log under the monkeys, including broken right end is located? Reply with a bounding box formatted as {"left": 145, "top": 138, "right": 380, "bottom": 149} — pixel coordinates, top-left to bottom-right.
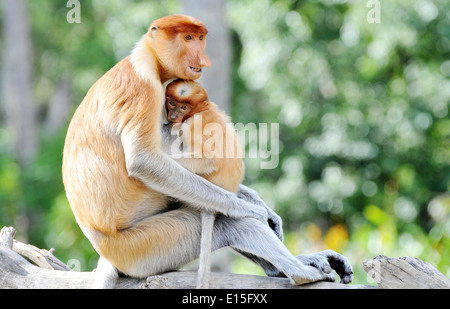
{"left": 0, "top": 227, "right": 450, "bottom": 289}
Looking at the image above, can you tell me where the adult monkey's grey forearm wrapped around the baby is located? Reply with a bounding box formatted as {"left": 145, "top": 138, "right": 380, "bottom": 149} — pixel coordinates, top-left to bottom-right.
{"left": 122, "top": 136, "right": 268, "bottom": 224}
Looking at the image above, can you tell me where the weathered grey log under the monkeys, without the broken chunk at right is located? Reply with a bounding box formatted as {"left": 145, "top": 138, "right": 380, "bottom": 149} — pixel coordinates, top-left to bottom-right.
{"left": 0, "top": 227, "right": 373, "bottom": 289}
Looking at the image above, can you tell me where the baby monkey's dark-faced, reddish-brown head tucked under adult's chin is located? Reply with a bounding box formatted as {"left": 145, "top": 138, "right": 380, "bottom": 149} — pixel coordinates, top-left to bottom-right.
{"left": 166, "top": 79, "right": 209, "bottom": 123}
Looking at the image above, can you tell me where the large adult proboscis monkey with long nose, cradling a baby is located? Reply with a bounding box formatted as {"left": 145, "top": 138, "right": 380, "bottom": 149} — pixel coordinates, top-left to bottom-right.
{"left": 63, "top": 15, "right": 352, "bottom": 287}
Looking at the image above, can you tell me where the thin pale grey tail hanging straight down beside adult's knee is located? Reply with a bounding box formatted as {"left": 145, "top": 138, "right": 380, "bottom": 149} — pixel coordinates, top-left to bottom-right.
{"left": 197, "top": 211, "right": 216, "bottom": 289}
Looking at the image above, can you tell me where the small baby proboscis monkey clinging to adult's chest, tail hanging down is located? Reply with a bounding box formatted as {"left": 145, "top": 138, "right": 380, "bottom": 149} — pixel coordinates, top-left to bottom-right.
{"left": 166, "top": 80, "right": 244, "bottom": 288}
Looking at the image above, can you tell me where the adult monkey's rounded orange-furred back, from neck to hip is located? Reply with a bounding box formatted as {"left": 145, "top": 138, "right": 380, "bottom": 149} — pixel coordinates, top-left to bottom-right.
{"left": 62, "top": 58, "right": 167, "bottom": 236}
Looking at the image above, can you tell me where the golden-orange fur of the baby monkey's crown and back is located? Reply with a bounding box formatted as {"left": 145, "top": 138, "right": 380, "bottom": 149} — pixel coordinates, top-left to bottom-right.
{"left": 166, "top": 80, "right": 244, "bottom": 193}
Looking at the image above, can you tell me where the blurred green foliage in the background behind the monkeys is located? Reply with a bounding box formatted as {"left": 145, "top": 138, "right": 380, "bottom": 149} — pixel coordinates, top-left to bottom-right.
{"left": 0, "top": 0, "right": 450, "bottom": 283}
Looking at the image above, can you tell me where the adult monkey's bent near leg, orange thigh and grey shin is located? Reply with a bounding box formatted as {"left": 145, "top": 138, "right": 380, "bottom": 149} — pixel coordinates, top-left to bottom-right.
{"left": 97, "top": 207, "right": 334, "bottom": 284}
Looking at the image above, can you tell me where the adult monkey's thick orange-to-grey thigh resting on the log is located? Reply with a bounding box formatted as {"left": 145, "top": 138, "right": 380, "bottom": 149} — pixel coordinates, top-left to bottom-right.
{"left": 101, "top": 207, "right": 201, "bottom": 278}
